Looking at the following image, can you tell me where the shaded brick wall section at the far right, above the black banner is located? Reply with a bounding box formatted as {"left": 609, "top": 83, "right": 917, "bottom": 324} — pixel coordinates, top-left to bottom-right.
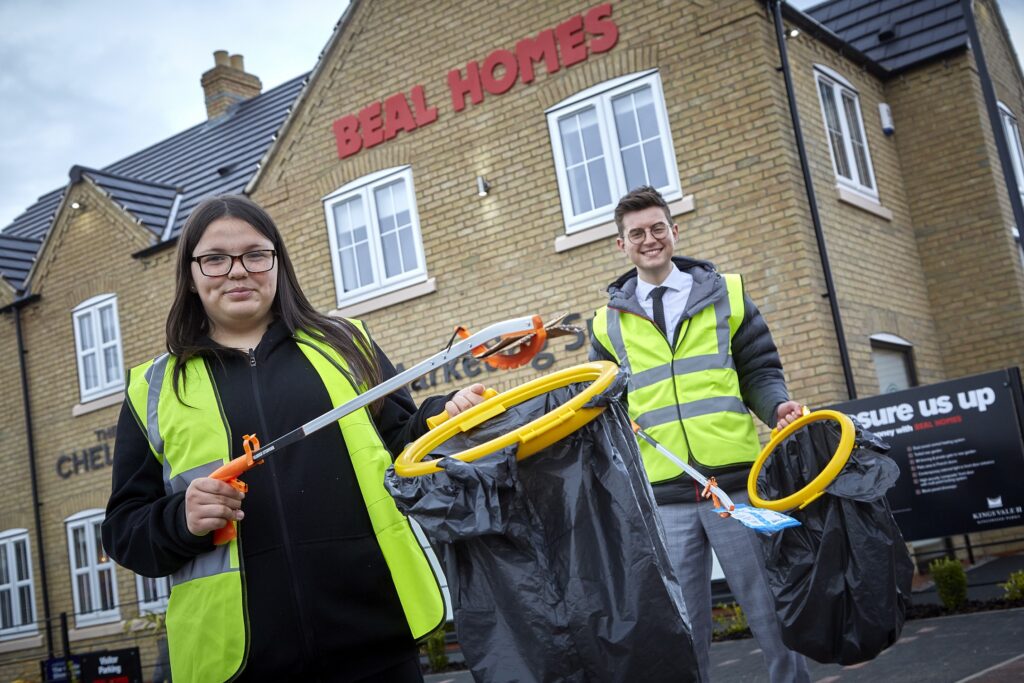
{"left": 887, "top": 3, "right": 1024, "bottom": 381}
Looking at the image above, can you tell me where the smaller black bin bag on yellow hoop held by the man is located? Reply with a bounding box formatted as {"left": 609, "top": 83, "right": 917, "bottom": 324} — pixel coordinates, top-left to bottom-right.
{"left": 757, "top": 420, "right": 913, "bottom": 665}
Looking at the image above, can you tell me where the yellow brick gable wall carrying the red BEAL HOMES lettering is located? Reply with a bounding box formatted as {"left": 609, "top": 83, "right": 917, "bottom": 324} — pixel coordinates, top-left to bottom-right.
{"left": 254, "top": 0, "right": 856, "bottom": 401}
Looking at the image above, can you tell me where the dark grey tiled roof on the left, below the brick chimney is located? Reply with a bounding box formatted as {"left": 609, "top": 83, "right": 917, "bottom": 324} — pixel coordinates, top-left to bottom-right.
{"left": 0, "top": 74, "right": 307, "bottom": 289}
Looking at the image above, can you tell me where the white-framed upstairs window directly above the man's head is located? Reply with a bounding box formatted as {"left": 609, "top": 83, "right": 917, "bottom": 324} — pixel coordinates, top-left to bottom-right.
{"left": 546, "top": 71, "right": 682, "bottom": 232}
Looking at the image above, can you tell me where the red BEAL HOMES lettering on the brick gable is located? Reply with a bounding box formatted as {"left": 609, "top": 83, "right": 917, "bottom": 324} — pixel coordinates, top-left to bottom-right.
{"left": 333, "top": 3, "right": 618, "bottom": 159}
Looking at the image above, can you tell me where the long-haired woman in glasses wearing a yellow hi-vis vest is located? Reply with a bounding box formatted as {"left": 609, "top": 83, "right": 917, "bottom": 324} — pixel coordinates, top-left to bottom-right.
{"left": 102, "top": 196, "right": 483, "bottom": 683}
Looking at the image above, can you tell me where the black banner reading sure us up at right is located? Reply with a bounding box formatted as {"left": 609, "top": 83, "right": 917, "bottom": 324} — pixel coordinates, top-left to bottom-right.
{"left": 834, "top": 368, "right": 1024, "bottom": 541}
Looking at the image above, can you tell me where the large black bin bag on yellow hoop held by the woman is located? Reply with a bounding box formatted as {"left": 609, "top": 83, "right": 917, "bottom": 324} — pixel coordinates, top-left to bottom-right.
{"left": 385, "top": 377, "right": 697, "bottom": 683}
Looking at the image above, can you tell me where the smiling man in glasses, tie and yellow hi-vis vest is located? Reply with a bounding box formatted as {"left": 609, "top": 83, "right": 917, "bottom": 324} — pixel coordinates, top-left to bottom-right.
{"left": 591, "top": 186, "right": 809, "bottom": 683}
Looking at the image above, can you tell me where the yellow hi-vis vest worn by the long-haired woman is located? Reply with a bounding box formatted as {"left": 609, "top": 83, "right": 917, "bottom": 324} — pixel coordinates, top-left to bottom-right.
{"left": 128, "top": 323, "right": 445, "bottom": 681}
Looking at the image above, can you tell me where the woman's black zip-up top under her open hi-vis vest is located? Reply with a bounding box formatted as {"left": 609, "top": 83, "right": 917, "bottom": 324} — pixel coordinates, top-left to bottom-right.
{"left": 102, "top": 323, "right": 444, "bottom": 681}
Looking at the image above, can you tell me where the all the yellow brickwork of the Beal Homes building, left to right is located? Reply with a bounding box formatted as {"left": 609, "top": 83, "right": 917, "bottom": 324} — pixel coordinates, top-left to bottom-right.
{"left": 0, "top": 0, "right": 1024, "bottom": 680}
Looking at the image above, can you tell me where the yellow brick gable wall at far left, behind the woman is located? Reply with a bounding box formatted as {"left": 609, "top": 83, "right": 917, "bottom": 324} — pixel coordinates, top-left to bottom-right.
{"left": 0, "top": 181, "right": 173, "bottom": 680}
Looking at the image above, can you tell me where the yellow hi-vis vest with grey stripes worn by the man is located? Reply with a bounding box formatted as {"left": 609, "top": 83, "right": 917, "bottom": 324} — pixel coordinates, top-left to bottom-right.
{"left": 594, "top": 274, "right": 760, "bottom": 483}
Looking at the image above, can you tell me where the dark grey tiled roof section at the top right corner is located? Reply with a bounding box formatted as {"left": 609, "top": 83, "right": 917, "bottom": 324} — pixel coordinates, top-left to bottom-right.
{"left": 804, "top": 0, "right": 968, "bottom": 74}
